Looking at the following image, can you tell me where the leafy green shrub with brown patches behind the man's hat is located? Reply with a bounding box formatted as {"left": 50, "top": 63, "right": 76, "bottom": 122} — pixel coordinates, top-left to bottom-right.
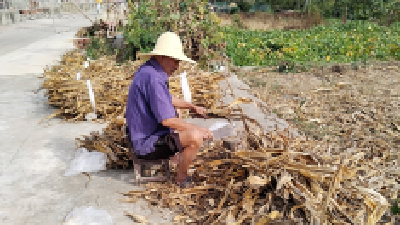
{"left": 124, "top": 0, "right": 224, "bottom": 66}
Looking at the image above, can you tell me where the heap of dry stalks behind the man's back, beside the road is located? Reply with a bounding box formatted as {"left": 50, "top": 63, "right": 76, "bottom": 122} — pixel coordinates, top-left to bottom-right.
{"left": 41, "top": 50, "right": 142, "bottom": 122}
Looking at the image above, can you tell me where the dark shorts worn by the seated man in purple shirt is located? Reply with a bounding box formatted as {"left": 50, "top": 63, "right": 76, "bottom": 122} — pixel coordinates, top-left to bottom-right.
{"left": 125, "top": 127, "right": 183, "bottom": 160}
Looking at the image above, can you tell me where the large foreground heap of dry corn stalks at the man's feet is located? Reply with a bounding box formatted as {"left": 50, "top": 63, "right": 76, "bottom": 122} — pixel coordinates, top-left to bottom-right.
{"left": 122, "top": 99, "right": 397, "bottom": 224}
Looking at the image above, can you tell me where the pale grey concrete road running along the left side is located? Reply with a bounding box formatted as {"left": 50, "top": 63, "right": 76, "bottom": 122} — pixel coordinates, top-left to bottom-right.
{"left": 0, "top": 9, "right": 174, "bottom": 225}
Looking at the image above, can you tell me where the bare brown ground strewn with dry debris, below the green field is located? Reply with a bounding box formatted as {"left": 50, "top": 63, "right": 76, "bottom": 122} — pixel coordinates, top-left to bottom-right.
{"left": 236, "top": 61, "right": 400, "bottom": 192}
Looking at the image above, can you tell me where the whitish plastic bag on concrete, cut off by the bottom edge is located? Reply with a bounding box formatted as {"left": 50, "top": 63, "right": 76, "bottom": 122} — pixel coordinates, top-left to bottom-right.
{"left": 64, "top": 206, "right": 113, "bottom": 225}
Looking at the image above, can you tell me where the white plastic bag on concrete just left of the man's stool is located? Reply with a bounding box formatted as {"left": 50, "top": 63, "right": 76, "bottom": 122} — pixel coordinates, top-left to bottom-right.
{"left": 64, "top": 148, "right": 107, "bottom": 177}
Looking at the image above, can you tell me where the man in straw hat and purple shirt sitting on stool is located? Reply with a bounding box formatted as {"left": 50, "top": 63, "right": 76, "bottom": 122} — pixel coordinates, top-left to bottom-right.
{"left": 126, "top": 32, "right": 213, "bottom": 187}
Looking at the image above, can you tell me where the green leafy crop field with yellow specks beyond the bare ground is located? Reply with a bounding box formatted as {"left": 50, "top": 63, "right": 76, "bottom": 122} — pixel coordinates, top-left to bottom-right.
{"left": 220, "top": 20, "right": 400, "bottom": 66}
